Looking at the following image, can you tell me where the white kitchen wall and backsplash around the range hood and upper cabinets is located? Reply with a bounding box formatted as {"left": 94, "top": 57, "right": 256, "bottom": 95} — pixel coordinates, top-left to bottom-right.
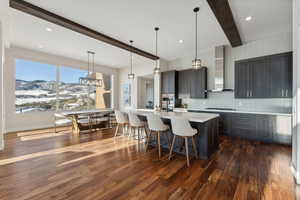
{"left": 169, "top": 32, "right": 292, "bottom": 112}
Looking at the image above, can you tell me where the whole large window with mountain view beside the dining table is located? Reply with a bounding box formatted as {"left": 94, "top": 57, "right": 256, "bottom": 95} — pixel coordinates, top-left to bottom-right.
{"left": 15, "top": 59, "right": 112, "bottom": 113}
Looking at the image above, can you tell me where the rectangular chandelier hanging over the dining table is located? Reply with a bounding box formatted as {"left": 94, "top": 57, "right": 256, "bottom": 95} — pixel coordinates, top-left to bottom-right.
{"left": 79, "top": 51, "right": 103, "bottom": 87}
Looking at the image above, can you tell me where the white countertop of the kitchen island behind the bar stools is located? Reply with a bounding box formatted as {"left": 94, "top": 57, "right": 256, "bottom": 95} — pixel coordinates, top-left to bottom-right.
{"left": 134, "top": 109, "right": 220, "bottom": 123}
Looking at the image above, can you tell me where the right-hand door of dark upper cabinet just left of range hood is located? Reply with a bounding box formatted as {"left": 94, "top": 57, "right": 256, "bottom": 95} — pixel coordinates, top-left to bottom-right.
{"left": 190, "top": 67, "right": 207, "bottom": 99}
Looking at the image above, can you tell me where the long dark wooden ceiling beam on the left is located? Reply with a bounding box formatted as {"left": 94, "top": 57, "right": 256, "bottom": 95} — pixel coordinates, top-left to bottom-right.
{"left": 9, "top": 0, "right": 159, "bottom": 60}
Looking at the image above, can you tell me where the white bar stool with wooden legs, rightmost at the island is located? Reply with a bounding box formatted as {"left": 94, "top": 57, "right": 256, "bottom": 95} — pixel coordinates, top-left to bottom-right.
{"left": 169, "top": 117, "right": 198, "bottom": 167}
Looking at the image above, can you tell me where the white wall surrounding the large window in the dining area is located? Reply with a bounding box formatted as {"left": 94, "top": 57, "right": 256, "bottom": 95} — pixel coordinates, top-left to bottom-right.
{"left": 4, "top": 47, "right": 119, "bottom": 132}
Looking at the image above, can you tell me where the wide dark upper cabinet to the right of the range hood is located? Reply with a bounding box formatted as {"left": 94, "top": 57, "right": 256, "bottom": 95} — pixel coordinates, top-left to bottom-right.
{"left": 235, "top": 52, "right": 293, "bottom": 98}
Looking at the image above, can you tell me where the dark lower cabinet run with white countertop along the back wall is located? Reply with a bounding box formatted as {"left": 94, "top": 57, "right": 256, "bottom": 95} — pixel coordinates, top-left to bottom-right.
{"left": 190, "top": 110, "right": 292, "bottom": 145}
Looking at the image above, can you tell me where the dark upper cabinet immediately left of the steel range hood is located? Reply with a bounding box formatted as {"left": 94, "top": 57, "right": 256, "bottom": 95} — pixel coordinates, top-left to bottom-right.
{"left": 178, "top": 67, "right": 207, "bottom": 99}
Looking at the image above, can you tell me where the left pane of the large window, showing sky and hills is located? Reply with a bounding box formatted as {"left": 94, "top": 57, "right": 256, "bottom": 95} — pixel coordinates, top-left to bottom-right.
{"left": 15, "top": 59, "right": 56, "bottom": 113}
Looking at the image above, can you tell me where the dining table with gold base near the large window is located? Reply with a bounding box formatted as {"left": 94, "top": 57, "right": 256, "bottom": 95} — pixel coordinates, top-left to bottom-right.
{"left": 61, "top": 108, "right": 114, "bottom": 135}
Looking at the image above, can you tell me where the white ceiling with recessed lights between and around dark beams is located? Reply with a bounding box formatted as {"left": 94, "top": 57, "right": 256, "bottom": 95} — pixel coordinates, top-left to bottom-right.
{"left": 3, "top": 0, "right": 292, "bottom": 68}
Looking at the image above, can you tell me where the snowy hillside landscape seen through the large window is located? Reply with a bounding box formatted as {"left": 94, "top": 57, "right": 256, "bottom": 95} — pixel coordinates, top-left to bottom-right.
{"left": 15, "top": 79, "right": 95, "bottom": 113}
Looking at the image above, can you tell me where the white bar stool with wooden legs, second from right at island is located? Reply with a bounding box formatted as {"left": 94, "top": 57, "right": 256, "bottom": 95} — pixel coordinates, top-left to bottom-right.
{"left": 146, "top": 114, "right": 170, "bottom": 159}
